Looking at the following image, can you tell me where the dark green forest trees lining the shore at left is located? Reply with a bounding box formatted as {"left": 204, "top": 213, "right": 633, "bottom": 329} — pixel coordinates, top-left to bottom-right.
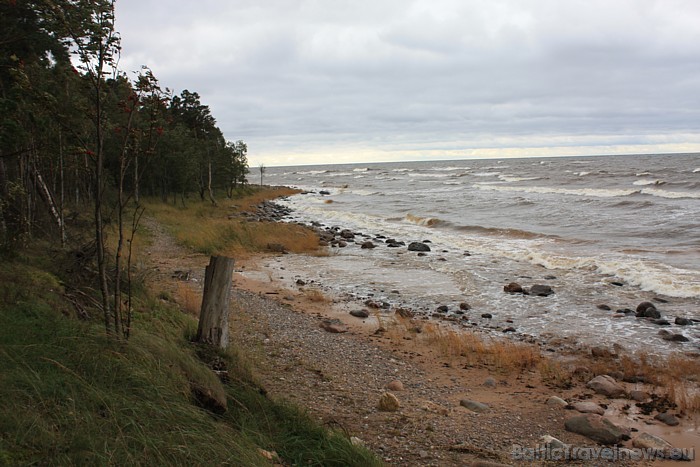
{"left": 0, "top": 0, "right": 248, "bottom": 336}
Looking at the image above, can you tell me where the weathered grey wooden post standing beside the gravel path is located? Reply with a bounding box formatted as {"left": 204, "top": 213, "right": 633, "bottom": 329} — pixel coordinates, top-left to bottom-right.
{"left": 197, "top": 256, "right": 234, "bottom": 349}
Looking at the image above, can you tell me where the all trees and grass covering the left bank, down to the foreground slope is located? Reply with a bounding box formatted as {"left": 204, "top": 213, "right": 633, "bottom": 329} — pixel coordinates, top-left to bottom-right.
{"left": 0, "top": 0, "right": 378, "bottom": 465}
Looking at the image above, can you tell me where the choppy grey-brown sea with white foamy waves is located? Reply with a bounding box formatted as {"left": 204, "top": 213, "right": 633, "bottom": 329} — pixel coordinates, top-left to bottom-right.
{"left": 258, "top": 154, "right": 700, "bottom": 355}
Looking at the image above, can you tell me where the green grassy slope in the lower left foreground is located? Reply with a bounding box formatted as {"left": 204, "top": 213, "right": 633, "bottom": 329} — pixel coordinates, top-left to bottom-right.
{"left": 0, "top": 189, "right": 379, "bottom": 466}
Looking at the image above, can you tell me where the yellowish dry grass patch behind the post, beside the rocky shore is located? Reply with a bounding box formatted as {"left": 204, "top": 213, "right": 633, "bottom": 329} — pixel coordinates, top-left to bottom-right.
{"left": 146, "top": 188, "right": 319, "bottom": 257}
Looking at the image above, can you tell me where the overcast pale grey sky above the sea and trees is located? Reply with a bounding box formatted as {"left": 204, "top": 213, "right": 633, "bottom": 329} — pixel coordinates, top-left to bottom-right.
{"left": 116, "top": 0, "right": 700, "bottom": 167}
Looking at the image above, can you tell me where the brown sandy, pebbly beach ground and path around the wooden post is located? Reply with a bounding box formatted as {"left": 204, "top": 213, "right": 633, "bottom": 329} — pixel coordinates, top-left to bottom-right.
{"left": 145, "top": 219, "right": 700, "bottom": 466}
